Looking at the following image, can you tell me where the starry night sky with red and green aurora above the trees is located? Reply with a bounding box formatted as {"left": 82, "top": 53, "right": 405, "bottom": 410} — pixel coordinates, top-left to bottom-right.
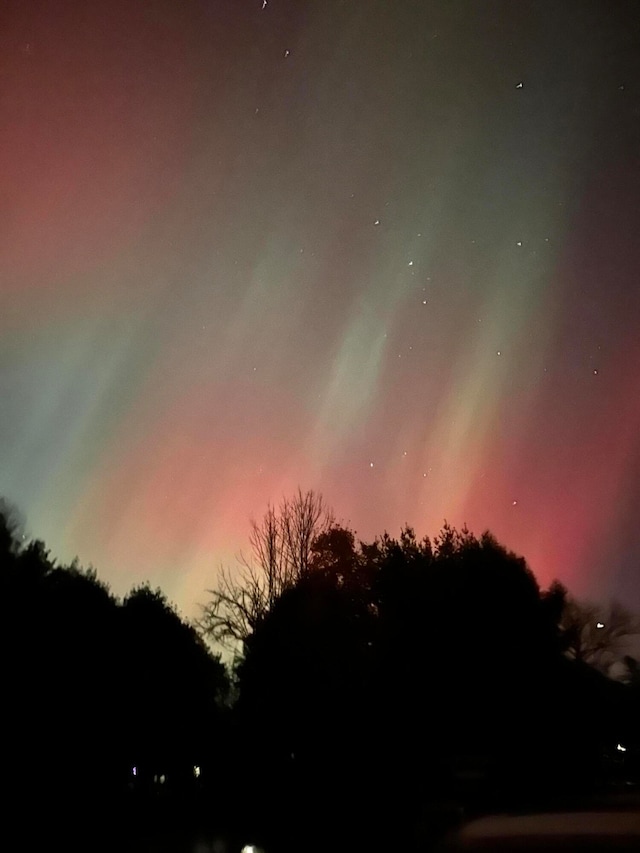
{"left": 0, "top": 0, "right": 640, "bottom": 616}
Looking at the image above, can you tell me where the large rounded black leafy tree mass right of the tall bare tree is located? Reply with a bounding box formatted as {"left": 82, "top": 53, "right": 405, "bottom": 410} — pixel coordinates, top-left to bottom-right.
{"left": 232, "top": 525, "right": 624, "bottom": 834}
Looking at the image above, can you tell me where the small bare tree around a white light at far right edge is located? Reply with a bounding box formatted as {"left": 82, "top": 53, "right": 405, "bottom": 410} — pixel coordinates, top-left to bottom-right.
{"left": 560, "top": 598, "right": 640, "bottom": 674}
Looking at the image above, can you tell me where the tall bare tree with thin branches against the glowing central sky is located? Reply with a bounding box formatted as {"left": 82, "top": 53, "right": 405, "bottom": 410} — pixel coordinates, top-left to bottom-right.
{"left": 198, "top": 489, "right": 335, "bottom": 651}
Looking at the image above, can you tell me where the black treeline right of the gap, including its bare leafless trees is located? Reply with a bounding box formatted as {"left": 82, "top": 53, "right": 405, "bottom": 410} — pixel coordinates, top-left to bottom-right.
{"left": 202, "top": 492, "right": 640, "bottom": 848}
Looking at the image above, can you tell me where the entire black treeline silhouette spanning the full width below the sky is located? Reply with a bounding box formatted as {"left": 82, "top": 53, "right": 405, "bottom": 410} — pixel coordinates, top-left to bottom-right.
{"left": 0, "top": 492, "right": 640, "bottom": 849}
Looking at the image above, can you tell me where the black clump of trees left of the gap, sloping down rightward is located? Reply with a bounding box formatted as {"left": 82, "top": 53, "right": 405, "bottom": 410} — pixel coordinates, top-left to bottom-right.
{"left": 0, "top": 506, "right": 229, "bottom": 823}
